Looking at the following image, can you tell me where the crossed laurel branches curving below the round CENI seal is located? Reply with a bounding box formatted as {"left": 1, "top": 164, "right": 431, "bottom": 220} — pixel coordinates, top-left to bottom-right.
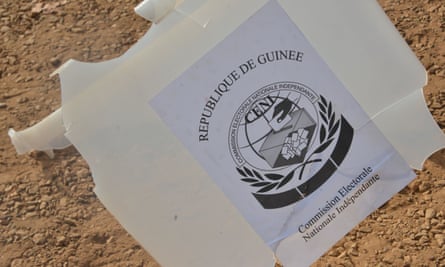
{"left": 236, "top": 95, "right": 340, "bottom": 193}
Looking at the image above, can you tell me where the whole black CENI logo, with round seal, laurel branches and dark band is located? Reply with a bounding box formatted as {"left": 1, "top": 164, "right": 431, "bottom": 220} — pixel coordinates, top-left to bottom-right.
{"left": 229, "top": 82, "right": 354, "bottom": 209}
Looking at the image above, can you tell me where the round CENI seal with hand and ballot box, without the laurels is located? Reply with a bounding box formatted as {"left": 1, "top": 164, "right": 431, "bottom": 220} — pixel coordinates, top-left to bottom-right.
{"left": 229, "top": 82, "right": 318, "bottom": 171}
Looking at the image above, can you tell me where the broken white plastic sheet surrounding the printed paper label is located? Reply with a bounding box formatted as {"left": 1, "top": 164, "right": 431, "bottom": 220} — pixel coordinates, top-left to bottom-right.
{"left": 7, "top": 0, "right": 445, "bottom": 267}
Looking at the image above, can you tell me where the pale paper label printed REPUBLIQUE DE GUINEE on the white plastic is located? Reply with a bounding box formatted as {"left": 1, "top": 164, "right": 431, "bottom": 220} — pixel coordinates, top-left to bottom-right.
{"left": 150, "top": 1, "right": 414, "bottom": 260}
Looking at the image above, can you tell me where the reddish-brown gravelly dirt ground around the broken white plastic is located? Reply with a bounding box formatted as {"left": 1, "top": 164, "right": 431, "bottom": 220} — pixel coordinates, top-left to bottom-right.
{"left": 0, "top": 0, "right": 445, "bottom": 267}
